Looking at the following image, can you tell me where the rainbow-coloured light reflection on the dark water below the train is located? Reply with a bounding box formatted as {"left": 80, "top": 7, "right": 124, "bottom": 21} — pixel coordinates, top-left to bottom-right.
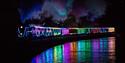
{"left": 31, "top": 37, "right": 115, "bottom": 63}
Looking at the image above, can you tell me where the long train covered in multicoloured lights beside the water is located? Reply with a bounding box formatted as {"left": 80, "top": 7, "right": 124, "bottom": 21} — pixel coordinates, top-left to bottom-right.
{"left": 17, "top": 25, "right": 115, "bottom": 37}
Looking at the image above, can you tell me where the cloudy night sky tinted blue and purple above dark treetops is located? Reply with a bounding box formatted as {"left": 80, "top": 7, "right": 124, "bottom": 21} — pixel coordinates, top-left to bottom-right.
{"left": 18, "top": 0, "right": 106, "bottom": 23}
